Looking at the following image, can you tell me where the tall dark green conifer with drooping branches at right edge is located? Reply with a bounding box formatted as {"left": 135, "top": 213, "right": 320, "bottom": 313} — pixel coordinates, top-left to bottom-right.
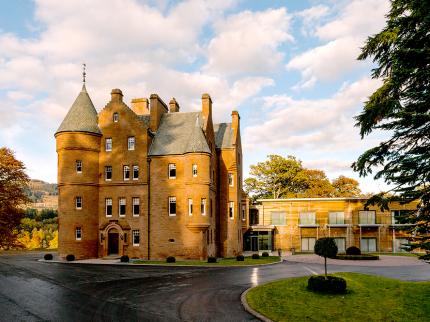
{"left": 353, "top": 0, "right": 430, "bottom": 250}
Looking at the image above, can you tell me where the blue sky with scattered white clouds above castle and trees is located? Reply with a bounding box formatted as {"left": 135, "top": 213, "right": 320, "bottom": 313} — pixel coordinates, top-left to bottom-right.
{"left": 0, "top": 0, "right": 389, "bottom": 192}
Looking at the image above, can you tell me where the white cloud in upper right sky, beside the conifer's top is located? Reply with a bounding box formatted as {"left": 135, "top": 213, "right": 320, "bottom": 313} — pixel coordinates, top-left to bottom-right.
{"left": 286, "top": 0, "right": 389, "bottom": 90}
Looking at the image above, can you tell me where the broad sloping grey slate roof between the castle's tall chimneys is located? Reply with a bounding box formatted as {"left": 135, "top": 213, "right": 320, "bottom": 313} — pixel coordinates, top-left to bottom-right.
{"left": 149, "top": 112, "right": 211, "bottom": 156}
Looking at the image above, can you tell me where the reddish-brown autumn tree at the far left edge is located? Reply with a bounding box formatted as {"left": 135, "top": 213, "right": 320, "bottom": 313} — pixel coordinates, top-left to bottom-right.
{"left": 0, "top": 148, "right": 29, "bottom": 249}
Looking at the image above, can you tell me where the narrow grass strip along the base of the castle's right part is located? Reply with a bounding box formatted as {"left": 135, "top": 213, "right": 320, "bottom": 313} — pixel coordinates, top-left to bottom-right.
{"left": 133, "top": 256, "right": 280, "bottom": 267}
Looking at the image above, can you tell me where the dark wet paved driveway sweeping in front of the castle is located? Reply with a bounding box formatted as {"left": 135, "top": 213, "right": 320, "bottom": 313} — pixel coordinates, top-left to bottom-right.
{"left": 0, "top": 252, "right": 430, "bottom": 321}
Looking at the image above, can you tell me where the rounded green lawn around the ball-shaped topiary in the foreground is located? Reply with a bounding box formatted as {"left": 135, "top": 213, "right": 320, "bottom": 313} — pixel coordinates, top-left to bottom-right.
{"left": 247, "top": 273, "right": 430, "bottom": 322}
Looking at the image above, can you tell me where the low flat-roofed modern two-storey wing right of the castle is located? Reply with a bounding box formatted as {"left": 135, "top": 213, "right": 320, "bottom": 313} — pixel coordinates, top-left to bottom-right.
{"left": 244, "top": 198, "right": 417, "bottom": 253}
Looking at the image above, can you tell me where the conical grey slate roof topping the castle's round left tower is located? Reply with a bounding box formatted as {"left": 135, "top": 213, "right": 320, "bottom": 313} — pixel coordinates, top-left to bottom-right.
{"left": 55, "top": 85, "right": 101, "bottom": 134}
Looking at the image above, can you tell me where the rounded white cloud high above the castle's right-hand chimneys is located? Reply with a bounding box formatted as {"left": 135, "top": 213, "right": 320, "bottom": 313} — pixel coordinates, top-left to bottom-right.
{"left": 204, "top": 8, "right": 293, "bottom": 75}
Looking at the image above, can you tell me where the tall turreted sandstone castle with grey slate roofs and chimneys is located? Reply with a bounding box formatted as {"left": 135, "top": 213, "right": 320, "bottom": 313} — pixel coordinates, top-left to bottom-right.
{"left": 55, "top": 84, "right": 248, "bottom": 259}
